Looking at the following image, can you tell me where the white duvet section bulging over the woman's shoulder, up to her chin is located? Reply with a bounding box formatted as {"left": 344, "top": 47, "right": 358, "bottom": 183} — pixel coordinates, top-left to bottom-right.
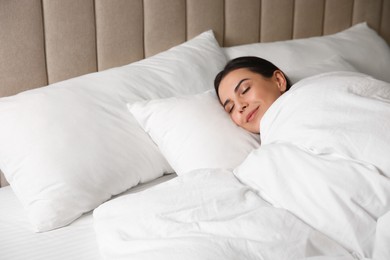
{"left": 260, "top": 72, "right": 390, "bottom": 177}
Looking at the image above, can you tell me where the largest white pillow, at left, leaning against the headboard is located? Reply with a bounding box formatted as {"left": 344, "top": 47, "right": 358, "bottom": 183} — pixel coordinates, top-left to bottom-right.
{"left": 0, "top": 31, "right": 226, "bottom": 231}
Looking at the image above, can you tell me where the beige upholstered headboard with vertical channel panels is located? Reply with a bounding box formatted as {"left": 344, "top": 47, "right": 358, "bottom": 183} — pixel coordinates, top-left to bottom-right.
{"left": 0, "top": 0, "right": 390, "bottom": 186}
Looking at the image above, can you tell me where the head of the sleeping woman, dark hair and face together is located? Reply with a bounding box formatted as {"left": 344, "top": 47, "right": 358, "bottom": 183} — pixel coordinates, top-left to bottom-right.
{"left": 214, "top": 56, "right": 291, "bottom": 133}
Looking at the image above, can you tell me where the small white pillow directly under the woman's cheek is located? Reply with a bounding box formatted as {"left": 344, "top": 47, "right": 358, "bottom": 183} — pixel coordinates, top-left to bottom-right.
{"left": 129, "top": 90, "right": 260, "bottom": 175}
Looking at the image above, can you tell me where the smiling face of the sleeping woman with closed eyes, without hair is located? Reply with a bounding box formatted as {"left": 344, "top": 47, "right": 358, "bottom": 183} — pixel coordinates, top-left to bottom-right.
{"left": 218, "top": 68, "right": 286, "bottom": 133}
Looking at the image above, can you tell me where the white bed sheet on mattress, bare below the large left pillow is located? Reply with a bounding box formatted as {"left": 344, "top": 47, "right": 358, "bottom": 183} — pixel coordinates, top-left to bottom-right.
{"left": 0, "top": 174, "right": 176, "bottom": 260}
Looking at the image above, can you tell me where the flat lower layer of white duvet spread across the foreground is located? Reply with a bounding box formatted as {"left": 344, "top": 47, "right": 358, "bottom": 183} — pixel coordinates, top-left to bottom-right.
{"left": 93, "top": 169, "right": 354, "bottom": 260}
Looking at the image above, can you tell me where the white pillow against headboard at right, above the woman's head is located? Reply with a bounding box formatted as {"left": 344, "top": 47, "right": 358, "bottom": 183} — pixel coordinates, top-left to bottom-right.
{"left": 224, "top": 23, "right": 390, "bottom": 82}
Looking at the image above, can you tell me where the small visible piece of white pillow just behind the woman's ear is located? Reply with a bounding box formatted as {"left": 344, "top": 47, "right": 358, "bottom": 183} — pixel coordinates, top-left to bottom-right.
{"left": 285, "top": 55, "right": 358, "bottom": 84}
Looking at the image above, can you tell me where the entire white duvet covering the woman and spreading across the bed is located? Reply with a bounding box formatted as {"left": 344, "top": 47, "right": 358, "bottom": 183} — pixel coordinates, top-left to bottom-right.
{"left": 94, "top": 73, "right": 390, "bottom": 260}
